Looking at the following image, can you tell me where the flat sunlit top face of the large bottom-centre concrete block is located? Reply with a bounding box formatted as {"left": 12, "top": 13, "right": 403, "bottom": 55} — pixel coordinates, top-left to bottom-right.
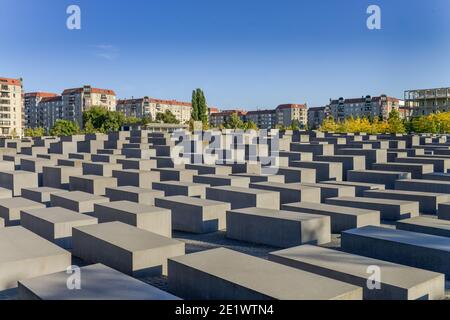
{"left": 169, "top": 248, "right": 360, "bottom": 300}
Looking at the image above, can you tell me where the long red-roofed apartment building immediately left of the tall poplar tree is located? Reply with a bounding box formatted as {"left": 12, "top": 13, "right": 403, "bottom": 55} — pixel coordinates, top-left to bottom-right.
{"left": 116, "top": 97, "right": 192, "bottom": 124}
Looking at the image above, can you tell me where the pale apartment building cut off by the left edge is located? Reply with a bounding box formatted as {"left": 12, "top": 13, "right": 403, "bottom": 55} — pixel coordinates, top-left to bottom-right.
{"left": 0, "top": 78, "right": 23, "bottom": 137}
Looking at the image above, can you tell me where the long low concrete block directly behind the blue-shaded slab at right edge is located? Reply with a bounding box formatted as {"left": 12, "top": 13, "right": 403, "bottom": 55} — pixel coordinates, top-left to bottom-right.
{"left": 325, "top": 197, "right": 419, "bottom": 220}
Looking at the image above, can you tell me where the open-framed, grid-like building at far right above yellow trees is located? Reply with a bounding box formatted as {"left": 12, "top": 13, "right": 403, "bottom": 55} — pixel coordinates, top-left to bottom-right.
{"left": 404, "top": 87, "right": 450, "bottom": 118}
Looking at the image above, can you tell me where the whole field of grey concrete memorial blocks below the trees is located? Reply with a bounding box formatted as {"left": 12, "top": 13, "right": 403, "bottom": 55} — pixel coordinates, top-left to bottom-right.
{"left": 0, "top": 130, "right": 450, "bottom": 300}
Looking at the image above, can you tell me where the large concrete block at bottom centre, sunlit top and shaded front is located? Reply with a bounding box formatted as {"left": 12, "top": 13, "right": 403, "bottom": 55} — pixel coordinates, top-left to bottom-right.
{"left": 169, "top": 248, "right": 362, "bottom": 300}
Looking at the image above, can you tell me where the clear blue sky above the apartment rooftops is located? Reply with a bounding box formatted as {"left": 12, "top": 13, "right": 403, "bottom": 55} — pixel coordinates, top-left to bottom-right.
{"left": 0, "top": 0, "right": 450, "bottom": 110}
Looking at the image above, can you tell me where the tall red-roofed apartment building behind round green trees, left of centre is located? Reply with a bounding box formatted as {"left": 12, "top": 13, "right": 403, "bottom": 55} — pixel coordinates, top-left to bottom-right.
{"left": 60, "top": 85, "right": 116, "bottom": 127}
